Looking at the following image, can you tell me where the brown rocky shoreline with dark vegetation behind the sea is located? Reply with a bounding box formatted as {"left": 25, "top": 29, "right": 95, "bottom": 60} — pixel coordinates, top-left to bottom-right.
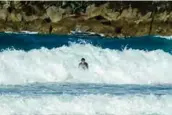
{"left": 0, "top": 1, "right": 172, "bottom": 37}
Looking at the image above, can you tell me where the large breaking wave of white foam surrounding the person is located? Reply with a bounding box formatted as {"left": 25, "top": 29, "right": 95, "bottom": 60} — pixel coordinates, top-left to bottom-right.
{"left": 0, "top": 44, "right": 172, "bottom": 84}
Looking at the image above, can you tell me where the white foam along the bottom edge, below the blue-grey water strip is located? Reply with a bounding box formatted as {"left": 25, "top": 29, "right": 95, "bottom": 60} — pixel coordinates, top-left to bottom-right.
{"left": 0, "top": 95, "right": 172, "bottom": 115}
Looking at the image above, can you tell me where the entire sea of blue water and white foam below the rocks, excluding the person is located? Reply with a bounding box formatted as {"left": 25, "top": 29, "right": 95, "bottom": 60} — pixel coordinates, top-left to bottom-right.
{"left": 0, "top": 33, "right": 172, "bottom": 115}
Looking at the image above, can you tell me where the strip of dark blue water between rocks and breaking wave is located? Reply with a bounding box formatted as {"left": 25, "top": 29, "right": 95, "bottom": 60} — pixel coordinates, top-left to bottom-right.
{"left": 0, "top": 33, "right": 172, "bottom": 53}
